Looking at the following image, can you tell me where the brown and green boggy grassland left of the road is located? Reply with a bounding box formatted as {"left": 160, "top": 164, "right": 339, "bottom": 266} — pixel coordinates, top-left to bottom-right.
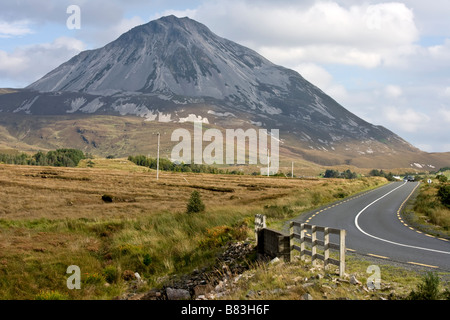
{"left": 0, "top": 159, "right": 386, "bottom": 299}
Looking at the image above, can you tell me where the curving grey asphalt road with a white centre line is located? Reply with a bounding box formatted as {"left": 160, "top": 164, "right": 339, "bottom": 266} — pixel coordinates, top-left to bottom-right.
{"left": 293, "top": 182, "right": 450, "bottom": 271}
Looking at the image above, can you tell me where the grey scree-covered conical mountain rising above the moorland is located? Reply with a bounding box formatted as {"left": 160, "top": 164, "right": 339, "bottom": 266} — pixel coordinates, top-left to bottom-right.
{"left": 0, "top": 16, "right": 450, "bottom": 167}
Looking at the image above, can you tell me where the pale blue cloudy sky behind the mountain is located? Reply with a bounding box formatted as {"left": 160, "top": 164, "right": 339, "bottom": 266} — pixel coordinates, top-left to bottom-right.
{"left": 0, "top": 0, "right": 450, "bottom": 152}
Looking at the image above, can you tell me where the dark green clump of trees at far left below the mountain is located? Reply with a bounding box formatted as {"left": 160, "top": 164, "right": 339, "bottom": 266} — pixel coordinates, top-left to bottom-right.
{"left": 0, "top": 149, "right": 88, "bottom": 167}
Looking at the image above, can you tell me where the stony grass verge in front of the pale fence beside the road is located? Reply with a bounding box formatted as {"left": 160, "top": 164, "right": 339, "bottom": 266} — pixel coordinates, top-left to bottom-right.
{"left": 220, "top": 254, "right": 450, "bottom": 300}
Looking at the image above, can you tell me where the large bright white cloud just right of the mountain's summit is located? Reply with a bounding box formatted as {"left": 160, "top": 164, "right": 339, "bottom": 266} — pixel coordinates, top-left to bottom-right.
{"left": 180, "top": 0, "right": 418, "bottom": 68}
